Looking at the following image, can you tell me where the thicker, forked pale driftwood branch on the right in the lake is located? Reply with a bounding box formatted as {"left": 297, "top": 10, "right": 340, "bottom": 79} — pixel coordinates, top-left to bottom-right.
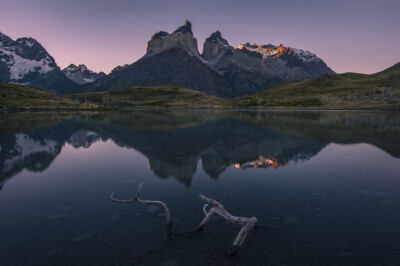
{"left": 197, "top": 194, "right": 257, "bottom": 255}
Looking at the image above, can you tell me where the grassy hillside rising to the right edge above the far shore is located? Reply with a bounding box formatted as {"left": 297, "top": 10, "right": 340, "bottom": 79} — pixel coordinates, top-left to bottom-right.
{"left": 232, "top": 63, "right": 400, "bottom": 109}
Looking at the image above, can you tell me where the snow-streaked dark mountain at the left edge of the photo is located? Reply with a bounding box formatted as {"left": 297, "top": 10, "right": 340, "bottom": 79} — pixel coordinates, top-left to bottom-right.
{"left": 0, "top": 32, "right": 78, "bottom": 93}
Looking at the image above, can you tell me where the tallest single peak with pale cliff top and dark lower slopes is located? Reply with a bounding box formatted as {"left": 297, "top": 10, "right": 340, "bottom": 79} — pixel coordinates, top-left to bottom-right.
{"left": 87, "top": 21, "right": 241, "bottom": 97}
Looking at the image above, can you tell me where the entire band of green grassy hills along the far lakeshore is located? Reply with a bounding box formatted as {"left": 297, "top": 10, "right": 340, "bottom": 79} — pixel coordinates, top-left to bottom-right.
{"left": 0, "top": 63, "right": 400, "bottom": 110}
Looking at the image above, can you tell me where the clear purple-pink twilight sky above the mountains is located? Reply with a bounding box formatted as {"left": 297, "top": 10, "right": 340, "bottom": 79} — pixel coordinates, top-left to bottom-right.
{"left": 0, "top": 0, "right": 400, "bottom": 73}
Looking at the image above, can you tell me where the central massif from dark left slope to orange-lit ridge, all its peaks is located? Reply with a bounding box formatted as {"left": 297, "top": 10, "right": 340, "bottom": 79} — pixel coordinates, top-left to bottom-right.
{"left": 85, "top": 20, "right": 334, "bottom": 98}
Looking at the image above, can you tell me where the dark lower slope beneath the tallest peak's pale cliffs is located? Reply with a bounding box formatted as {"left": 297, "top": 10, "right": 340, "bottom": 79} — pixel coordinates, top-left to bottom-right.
{"left": 85, "top": 48, "right": 235, "bottom": 96}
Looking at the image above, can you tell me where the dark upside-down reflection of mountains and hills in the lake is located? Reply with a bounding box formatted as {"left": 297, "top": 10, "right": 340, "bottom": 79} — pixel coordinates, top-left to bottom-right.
{"left": 0, "top": 110, "right": 400, "bottom": 189}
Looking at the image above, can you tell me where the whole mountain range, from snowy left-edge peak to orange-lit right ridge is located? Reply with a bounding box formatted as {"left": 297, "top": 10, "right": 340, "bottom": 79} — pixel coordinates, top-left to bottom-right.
{"left": 0, "top": 19, "right": 334, "bottom": 98}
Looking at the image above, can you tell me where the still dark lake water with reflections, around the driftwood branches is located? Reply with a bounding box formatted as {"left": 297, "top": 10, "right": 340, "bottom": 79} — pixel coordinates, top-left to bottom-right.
{"left": 0, "top": 110, "right": 400, "bottom": 266}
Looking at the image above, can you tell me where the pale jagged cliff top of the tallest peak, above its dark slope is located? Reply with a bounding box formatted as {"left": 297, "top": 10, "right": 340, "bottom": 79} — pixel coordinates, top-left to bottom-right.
{"left": 145, "top": 20, "right": 200, "bottom": 57}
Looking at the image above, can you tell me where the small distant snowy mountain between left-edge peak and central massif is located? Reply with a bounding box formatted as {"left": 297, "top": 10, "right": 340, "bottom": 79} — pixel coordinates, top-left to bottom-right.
{"left": 62, "top": 64, "right": 106, "bottom": 85}
